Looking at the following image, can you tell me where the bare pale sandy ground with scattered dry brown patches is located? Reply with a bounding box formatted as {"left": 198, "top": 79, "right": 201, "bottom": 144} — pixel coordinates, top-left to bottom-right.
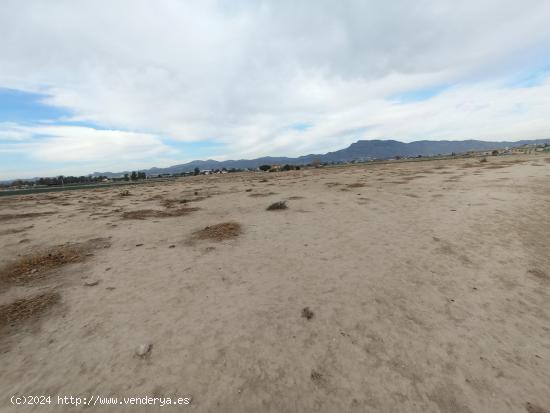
{"left": 0, "top": 155, "right": 550, "bottom": 413}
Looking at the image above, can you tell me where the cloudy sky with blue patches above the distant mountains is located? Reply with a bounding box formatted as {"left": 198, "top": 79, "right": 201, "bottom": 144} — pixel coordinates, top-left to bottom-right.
{"left": 0, "top": 0, "right": 550, "bottom": 179}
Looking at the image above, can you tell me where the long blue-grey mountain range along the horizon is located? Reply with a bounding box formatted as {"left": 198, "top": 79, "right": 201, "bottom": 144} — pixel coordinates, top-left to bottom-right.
{"left": 92, "top": 139, "right": 550, "bottom": 177}
